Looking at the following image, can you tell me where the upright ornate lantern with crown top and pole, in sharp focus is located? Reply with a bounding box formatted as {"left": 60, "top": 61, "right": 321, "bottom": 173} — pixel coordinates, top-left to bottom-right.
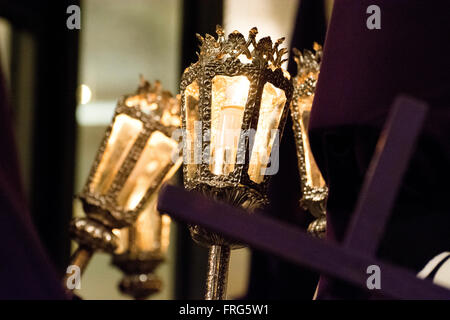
{"left": 181, "top": 26, "right": 293, "bottom": 299}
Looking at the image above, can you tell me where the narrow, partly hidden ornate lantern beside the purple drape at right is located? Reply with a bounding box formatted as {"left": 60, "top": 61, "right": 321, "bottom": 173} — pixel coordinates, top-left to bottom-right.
{"left": 290, "top": 43, "right": 328, "bottom": 237}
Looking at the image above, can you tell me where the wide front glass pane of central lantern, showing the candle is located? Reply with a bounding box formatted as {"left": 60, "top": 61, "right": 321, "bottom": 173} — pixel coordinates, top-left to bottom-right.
{"left": 210, "top": 76, "right": 250, "bottom": 175}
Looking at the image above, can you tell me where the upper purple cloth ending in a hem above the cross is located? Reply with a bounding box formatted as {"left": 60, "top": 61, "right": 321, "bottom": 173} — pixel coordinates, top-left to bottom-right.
{"left": 311, "top": 0, "right": 450, "bottom": 129}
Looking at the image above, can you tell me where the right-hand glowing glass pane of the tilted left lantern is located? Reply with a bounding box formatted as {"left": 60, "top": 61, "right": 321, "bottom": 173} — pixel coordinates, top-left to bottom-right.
{"left": 117, "top": 131, "right": 178, "bottom": 210}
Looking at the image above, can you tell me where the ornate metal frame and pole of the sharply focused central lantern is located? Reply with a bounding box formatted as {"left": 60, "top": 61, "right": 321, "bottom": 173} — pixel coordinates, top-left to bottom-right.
{"left": 180, "top": 26, "right": 294, "bottom": 299}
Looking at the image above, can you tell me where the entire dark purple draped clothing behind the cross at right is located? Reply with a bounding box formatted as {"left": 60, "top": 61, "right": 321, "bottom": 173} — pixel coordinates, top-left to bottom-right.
{"left": 310, "top": 0, "right": 450, "bottom": 298}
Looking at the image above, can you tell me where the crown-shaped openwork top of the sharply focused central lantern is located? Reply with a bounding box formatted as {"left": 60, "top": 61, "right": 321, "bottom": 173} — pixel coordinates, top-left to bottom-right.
{"left": 197, "top": 25, "right": 288, "bottom": 69}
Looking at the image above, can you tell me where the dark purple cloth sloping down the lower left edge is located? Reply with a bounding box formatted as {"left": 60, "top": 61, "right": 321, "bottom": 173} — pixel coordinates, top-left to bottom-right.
{"left": 0, "top": 63, "right": 67, "bottom": 299}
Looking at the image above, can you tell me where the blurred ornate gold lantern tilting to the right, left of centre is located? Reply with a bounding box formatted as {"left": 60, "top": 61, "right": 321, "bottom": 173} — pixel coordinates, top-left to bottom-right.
{"left": 65, "top": 77, "right": 181, "bottom": 288}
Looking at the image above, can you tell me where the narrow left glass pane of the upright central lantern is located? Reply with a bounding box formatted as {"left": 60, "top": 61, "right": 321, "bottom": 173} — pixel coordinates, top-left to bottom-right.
{"left": 184, "top": 81, "right": 202, "bottom": 178}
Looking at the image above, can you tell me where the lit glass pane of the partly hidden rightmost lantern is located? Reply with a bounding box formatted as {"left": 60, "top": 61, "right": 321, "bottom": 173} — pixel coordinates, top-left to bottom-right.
{"left": 297, "top": 95, "right": 326, "bottom": 188}
